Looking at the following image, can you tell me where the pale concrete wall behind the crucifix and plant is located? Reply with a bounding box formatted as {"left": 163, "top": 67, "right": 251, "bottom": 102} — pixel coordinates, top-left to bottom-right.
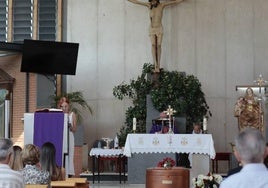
{"left": 64, "top": 0, "right": 268, "bottom": 151}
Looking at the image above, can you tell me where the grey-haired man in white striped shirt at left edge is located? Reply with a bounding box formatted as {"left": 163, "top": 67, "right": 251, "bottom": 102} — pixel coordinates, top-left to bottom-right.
{"left": 0, "top": 138, "right": 25, "bottom": 188}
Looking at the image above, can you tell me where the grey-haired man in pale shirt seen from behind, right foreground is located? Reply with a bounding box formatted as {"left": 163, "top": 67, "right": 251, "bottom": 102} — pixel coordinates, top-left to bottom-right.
{"left": 220, "top": 128, "right": 268, "bottom": 188}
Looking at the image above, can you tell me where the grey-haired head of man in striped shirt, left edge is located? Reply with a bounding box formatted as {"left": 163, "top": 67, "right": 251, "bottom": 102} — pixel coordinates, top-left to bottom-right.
{"left": 0, "top": 138, "right": 13, "bottom": 164}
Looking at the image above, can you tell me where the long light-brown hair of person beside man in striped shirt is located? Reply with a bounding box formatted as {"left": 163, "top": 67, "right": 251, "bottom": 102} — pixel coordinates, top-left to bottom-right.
{"left": 9, "top": 145, "right": 23, "bottom": 170}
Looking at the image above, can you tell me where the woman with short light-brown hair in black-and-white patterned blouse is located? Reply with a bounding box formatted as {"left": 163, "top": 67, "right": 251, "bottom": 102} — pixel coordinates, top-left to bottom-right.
{"left": 21, "top": 144, "right": 50, "bottom": 184}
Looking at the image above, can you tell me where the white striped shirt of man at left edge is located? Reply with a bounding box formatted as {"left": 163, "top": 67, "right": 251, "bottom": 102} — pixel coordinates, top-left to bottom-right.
{"left": 0, "top": 164, "right": 25, "bottom": 188}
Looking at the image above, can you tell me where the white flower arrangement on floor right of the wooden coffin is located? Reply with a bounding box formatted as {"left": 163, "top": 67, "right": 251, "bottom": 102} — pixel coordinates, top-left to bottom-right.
{"left": 192, "top": 173, "right": 222, "bottom": 188}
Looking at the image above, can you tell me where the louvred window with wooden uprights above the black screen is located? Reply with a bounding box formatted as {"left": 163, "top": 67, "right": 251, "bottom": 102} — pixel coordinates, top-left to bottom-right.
{"left": 0, "top": 0, "right": 61, "bottom": 43}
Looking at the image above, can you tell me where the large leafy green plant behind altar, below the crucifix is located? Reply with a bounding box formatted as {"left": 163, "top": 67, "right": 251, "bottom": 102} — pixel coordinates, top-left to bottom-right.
{"left": 113, "top": 63, "right": 211, "bottom": 146}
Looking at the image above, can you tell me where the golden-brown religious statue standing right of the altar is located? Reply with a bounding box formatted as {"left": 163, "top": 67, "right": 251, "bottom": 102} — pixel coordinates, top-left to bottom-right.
{"left": 234, "top": 87, "right": 263, "bottom": 131}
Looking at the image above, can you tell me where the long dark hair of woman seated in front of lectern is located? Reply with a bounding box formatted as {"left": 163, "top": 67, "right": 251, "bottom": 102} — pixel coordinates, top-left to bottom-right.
{"left": 40, "top": 142, "right": 58, "bottom": 181}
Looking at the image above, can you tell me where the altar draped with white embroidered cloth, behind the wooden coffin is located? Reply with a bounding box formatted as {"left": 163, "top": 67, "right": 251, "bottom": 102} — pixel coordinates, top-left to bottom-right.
{"left": 124, "top": 134, "right": 215, "bottom": 184}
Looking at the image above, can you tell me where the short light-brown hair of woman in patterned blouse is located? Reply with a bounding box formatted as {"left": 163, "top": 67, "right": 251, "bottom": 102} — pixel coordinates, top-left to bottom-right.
{"left": 21, "top": 144, "right": 40, "bottom": 165}
